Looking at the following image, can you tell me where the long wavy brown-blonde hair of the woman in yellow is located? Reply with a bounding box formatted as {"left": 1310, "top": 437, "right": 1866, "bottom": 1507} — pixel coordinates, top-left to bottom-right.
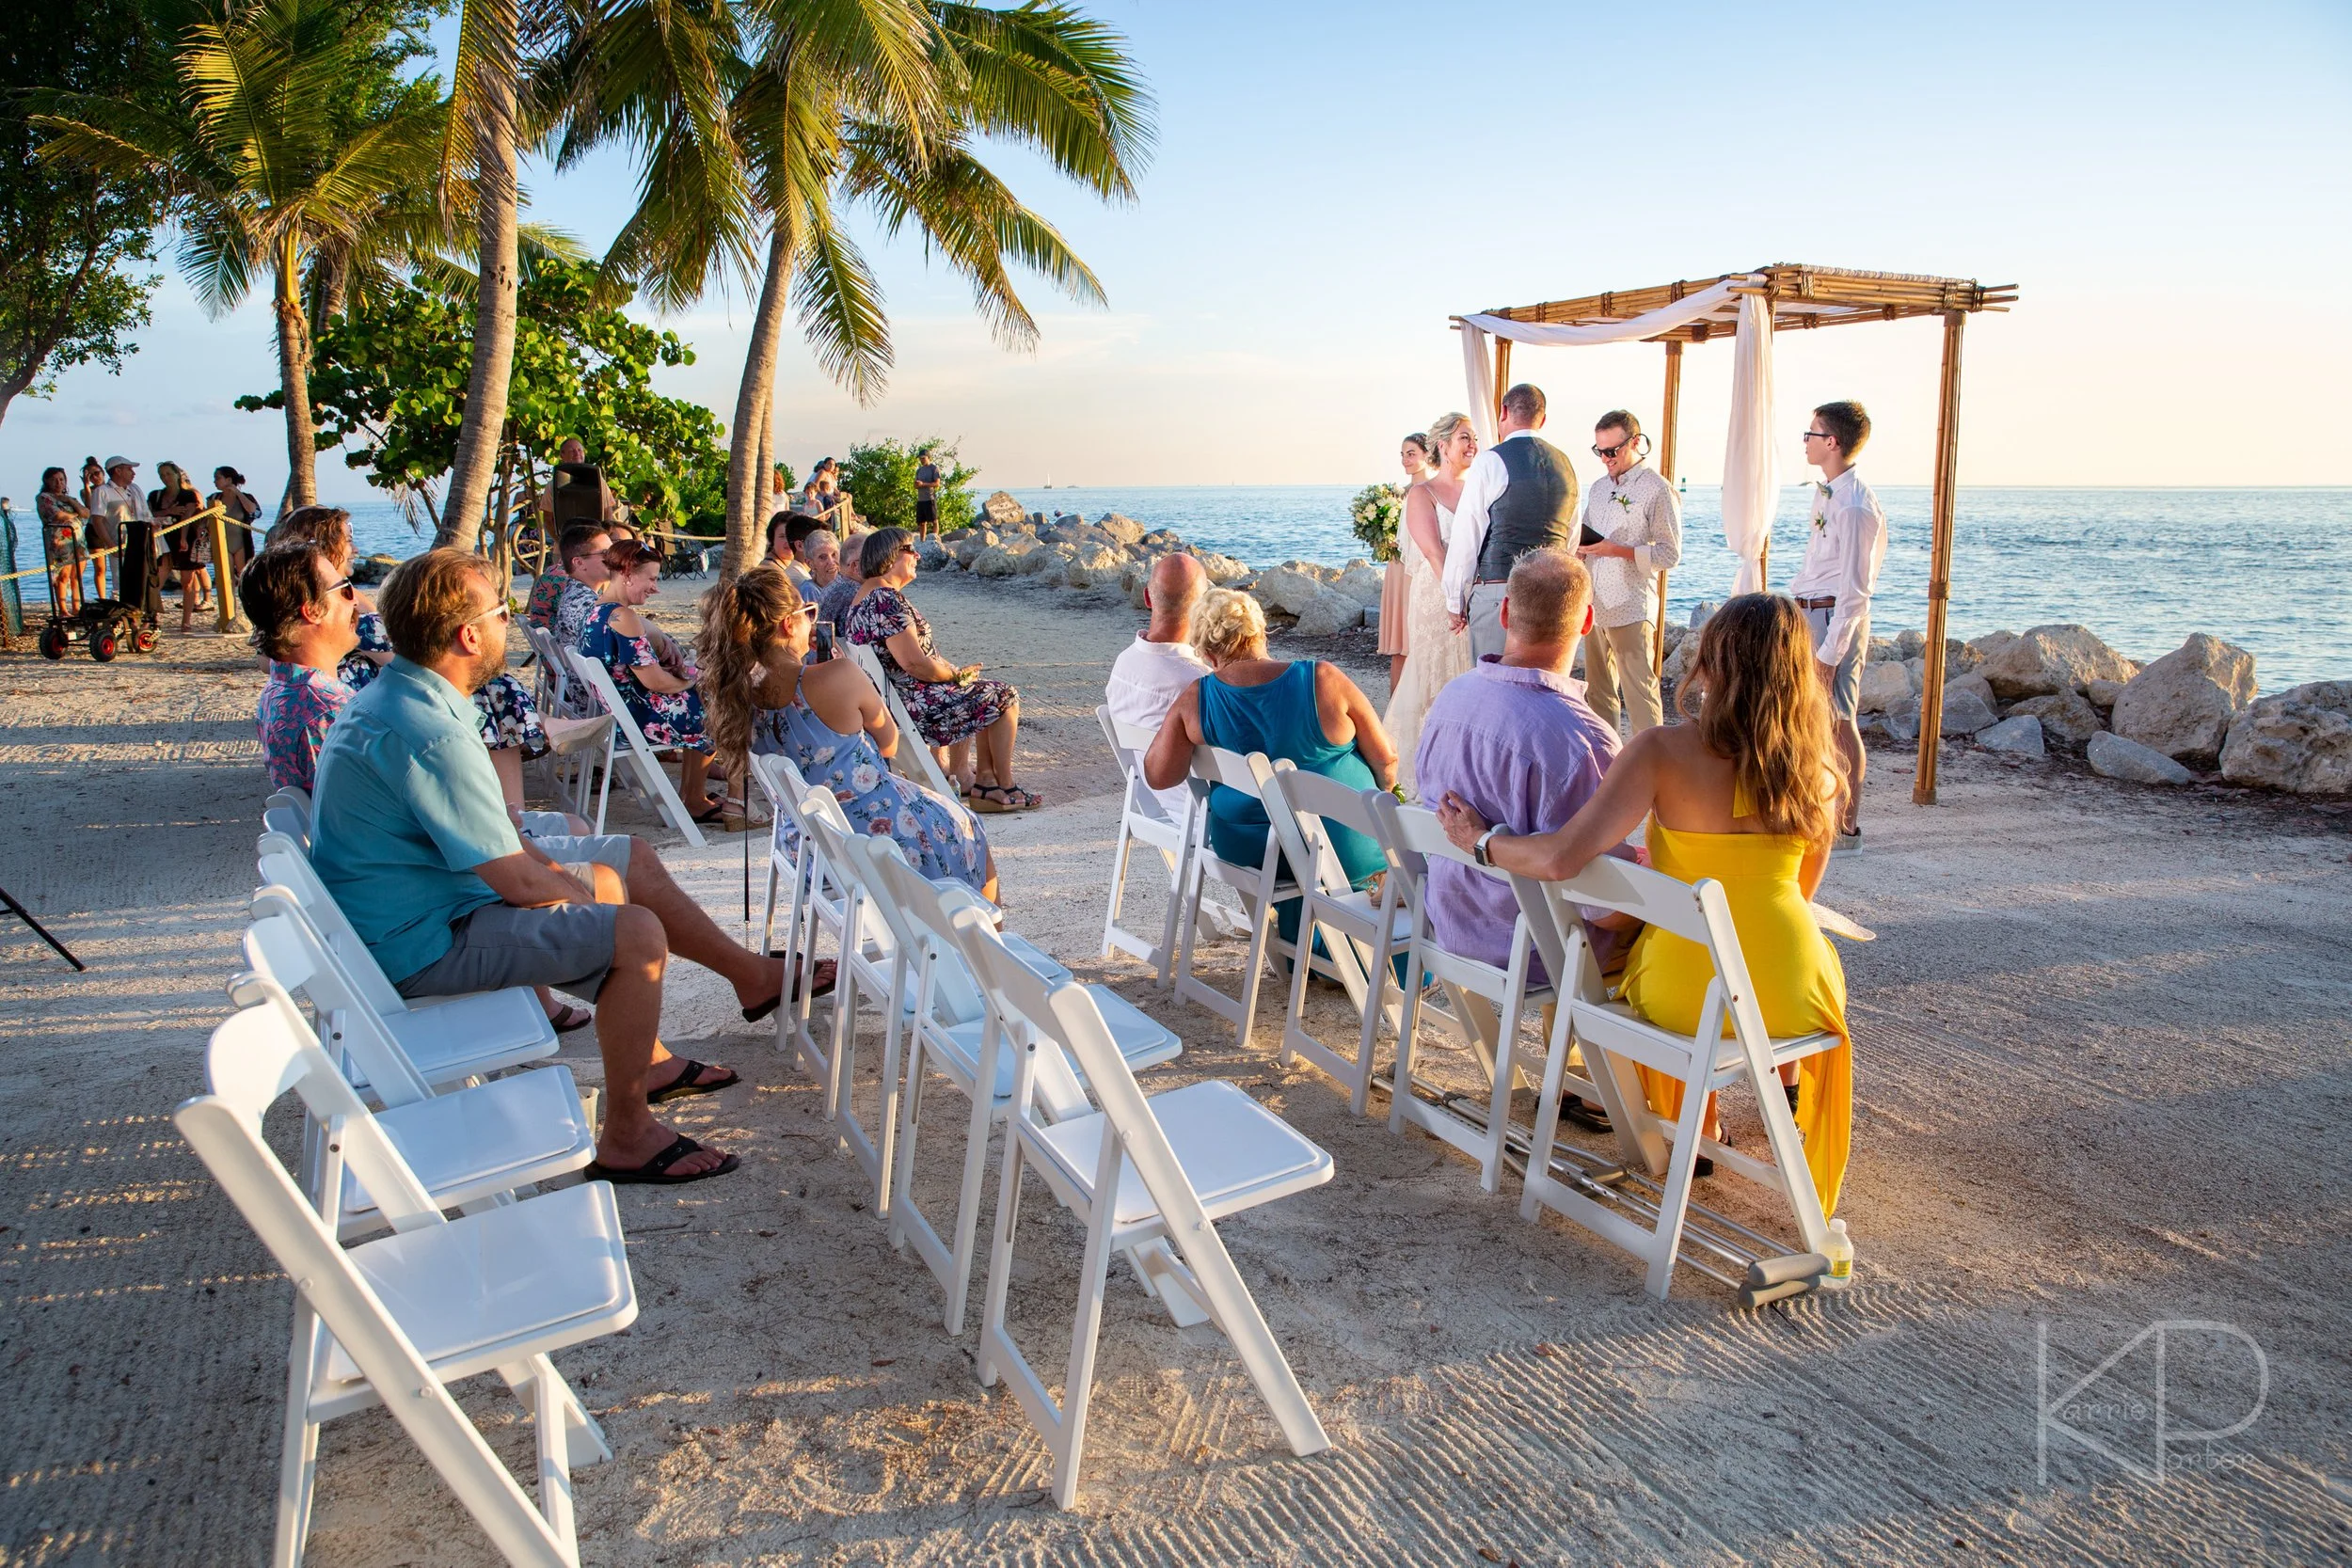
{"left": 1675, "top": 593, "right": 1847, "bottom": 844}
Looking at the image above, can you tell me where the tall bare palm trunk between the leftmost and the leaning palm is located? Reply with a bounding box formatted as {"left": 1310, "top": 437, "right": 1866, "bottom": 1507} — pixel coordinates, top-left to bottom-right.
{"left": 433, "top": 0, "right": 517, "bottom": 550}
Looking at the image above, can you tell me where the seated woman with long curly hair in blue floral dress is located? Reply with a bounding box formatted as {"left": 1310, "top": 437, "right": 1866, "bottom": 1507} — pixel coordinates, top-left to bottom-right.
{"left": 701, "top": 562, "right": 997, "bottom": 903}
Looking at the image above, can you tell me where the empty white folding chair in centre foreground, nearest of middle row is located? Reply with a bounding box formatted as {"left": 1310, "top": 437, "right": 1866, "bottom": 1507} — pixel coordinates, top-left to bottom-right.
{"left": 950, "top": 910, "right": 1331, "bottom": 1507}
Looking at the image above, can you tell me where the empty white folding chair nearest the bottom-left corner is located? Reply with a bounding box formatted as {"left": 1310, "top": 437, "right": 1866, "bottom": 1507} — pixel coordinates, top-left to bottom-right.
{"left": 172, "top": 988, "right": 638, "bottom": 1568}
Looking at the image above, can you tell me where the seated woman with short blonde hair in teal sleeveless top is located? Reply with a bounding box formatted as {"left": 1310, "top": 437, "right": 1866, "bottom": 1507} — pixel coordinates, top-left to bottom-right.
{"left": 1143, "top": 588, "right": 1397, "bottom": 941}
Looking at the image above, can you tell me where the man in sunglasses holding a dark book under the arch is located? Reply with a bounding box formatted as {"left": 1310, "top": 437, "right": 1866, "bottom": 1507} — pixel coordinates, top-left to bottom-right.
{"left": 1576, "top": 409, "right": 1682, "bottom": 736}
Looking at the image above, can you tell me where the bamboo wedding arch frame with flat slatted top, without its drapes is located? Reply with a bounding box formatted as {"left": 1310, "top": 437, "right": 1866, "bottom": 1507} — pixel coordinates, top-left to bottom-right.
{"left": 1454, "top": 261, "right": 2018, "bottom": 806}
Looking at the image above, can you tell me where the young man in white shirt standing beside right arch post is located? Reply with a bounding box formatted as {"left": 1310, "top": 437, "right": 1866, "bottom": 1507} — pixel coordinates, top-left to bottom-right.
{"left": 1788, "top": 402, "right": 1886, "bottom": 851}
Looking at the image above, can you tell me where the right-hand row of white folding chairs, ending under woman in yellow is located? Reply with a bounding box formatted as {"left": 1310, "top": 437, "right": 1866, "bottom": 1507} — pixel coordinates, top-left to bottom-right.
{"left": 1096, "top": 707, "right": 1867, "bottom": 1303}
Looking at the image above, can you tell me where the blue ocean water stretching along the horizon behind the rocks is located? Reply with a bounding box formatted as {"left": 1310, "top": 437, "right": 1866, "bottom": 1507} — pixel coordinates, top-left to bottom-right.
{"left": 17, "top": 484, "right": 2352, "bottom": 691}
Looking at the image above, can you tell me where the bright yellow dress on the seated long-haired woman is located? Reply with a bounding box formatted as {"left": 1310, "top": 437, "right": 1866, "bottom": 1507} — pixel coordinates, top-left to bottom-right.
{"left": 1618, "top": 800, "right": 1853, "bottom": 1213}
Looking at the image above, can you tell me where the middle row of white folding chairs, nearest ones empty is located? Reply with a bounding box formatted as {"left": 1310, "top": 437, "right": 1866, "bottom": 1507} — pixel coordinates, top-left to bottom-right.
{"left": 753, "top": 757, "right": 1331, "bottom": 1507}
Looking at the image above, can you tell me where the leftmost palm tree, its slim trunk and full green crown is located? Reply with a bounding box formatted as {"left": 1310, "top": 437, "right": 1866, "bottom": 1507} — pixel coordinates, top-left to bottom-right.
{"left": 33, "top": 0, "right": 445, "bottom": 505}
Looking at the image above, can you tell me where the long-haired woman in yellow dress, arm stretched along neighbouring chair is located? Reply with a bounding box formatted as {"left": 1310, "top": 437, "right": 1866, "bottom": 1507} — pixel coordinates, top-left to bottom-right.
{"left": 1438, "top": 593, "right": 1853, "bottom": 1213}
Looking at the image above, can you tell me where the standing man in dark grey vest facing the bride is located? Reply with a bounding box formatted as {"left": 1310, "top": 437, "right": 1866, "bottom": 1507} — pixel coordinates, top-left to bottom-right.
{"left": 1444, "top": 381, "right": 1576, "bottom": 658}
